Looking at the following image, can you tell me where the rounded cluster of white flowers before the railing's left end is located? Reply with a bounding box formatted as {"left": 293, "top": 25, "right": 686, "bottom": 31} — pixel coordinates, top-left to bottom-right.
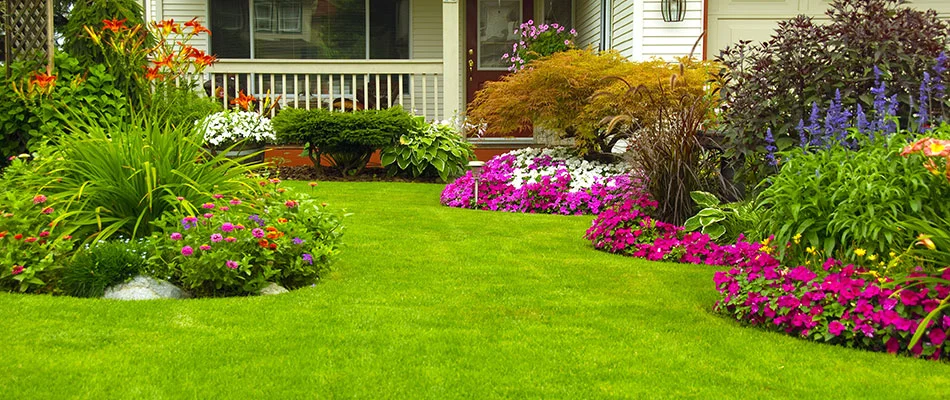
{"left": 196, "top": 110, "right": 277, "bottom": 148}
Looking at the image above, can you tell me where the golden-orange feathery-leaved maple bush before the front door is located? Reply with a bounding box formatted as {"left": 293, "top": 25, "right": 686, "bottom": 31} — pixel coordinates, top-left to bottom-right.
{"left": 469, "top": 50, "right": 713, "bottom": 155}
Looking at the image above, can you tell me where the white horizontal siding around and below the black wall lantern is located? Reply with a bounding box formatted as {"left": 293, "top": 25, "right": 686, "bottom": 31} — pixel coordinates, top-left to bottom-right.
{"left": 641, "top": 0, "right": 703, "bottom": 59}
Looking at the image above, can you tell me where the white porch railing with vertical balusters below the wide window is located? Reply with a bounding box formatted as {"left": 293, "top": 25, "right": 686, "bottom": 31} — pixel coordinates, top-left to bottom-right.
{"left": 204, "top": 60, "right": 447, "bottom": 120}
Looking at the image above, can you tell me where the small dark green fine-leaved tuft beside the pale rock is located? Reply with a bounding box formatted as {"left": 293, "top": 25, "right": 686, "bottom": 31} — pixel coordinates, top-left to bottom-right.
{"left": 60, "top": 241, "right": 148, "bottom": 297}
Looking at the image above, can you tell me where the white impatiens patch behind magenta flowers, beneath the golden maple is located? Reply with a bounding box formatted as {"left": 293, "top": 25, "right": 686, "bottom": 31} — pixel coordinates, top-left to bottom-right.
{"left": 508, "top": 147, "right": 629, "bottom": 191}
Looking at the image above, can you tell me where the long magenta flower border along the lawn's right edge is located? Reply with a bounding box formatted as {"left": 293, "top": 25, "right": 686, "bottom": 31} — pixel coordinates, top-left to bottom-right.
{"left": 585, "top": 196, "right": 950, "bottom": 359}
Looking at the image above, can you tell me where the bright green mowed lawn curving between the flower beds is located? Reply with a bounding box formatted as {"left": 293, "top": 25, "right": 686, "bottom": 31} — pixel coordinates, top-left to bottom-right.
{"left": 0, "top": 183, "right": 950, "bottom": 399}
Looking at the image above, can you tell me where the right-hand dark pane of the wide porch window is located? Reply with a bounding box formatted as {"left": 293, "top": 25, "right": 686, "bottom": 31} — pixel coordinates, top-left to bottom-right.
{"left": 369, "top": 0, "right": 410, "bottom": 59}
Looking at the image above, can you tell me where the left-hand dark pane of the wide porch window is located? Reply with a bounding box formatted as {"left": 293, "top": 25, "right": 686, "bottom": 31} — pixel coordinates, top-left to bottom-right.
{"left": 209, "top": 0, "right": 251, "bottom": 58}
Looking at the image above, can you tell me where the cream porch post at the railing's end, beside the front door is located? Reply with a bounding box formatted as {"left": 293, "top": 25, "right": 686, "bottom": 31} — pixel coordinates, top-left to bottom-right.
{"left": 442, "top": 0, "right": 465, "bottom": 119}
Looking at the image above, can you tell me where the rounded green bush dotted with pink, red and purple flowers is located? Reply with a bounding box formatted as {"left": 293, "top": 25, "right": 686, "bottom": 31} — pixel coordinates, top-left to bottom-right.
{"left": 151, "top": 179, "right": 343, "bottom": 296}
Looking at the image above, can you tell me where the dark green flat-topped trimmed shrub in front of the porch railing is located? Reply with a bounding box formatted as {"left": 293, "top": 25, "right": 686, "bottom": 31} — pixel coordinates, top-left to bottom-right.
{"left": 272, "top": 107, "right": 413, "bottom": 176}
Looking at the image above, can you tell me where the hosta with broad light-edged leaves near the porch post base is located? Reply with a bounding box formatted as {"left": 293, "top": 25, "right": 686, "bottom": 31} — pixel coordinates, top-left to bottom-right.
{"left": 380, "top": 116, "right": 475, "bottom": 182}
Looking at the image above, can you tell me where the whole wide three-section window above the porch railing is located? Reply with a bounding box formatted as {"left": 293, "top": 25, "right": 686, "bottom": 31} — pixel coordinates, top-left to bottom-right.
{"left": 209, "top": 0, "right": 411, "bottom": 59}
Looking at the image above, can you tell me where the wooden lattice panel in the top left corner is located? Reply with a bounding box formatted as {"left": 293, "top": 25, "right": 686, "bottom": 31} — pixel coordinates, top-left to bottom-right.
{"left": 5, "top": 0, "right": 51, "bottom": 65}
